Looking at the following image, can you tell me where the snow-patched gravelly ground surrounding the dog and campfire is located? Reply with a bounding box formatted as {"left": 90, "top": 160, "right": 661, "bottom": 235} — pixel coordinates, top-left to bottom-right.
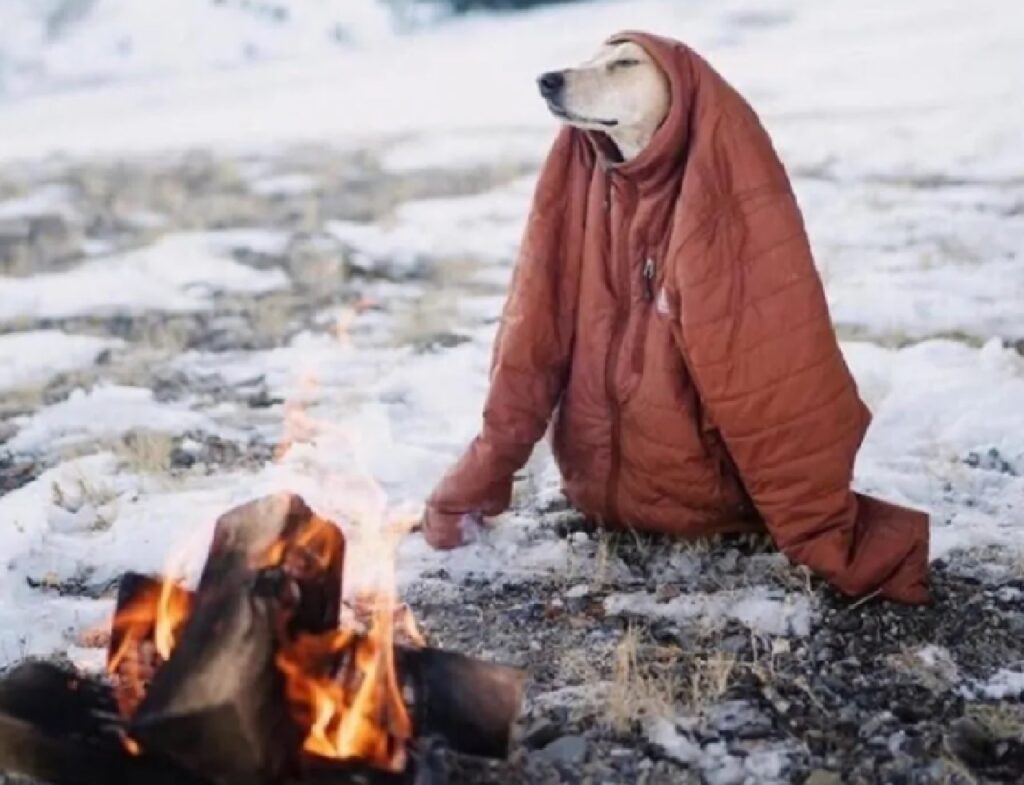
{"left": 0, "top": 0, "right": 1024, "bottom": 785}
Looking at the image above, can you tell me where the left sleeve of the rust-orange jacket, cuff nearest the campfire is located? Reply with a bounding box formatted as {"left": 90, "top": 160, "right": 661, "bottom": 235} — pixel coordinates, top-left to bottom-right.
{"left": 428, "top": 129, "right": 588, "bottom": 516}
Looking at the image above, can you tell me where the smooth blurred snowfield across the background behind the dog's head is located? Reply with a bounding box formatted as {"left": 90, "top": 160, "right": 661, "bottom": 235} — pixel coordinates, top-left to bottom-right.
{"left": 0, "top": 0, "right": 1024, "bottom": 179}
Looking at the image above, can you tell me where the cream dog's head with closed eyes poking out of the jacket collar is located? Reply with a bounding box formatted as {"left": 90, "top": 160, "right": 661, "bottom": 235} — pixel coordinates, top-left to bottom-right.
{"left": 537, "top": 41, "right": 670, "bottom": 134}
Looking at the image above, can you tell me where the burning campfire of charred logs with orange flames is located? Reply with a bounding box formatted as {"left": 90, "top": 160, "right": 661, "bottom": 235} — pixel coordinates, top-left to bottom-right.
{"left": 0, "top": 494, "right": 523, "bottom": 785}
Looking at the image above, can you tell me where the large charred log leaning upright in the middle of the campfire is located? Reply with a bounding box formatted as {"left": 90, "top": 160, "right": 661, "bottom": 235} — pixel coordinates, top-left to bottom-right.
{"left": 129, "top": 494, "right": 344, "bottom": 785}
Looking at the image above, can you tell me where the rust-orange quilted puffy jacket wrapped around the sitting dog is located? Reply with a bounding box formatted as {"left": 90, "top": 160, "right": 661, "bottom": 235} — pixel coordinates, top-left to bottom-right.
{"left": 424, "top": 33, "right": 928, "bottom": 603}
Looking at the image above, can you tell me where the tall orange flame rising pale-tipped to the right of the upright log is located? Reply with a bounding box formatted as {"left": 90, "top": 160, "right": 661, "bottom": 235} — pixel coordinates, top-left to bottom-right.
{"left": 268, "top": 311, "right": 423, "bottom": 772}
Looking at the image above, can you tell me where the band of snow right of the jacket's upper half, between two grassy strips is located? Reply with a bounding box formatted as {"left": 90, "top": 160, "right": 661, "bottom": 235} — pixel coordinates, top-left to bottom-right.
{"left": 797, "top": 178, "right": 1024, "bottom": 342}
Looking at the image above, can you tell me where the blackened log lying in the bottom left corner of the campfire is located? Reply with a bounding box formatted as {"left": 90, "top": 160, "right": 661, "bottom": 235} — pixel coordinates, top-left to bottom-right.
{"left": 0, "top": 662, "right": 208, "bottom": 785}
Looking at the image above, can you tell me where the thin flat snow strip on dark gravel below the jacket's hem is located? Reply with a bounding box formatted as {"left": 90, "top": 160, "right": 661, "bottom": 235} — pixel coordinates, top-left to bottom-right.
{"left": 604, "top": 586, "right": 813, "bottom": 637}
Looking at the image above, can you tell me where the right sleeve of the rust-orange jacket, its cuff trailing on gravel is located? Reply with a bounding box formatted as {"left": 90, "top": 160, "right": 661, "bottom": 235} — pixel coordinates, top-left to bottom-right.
{"left": 676, "top": 112, "right": 928, "bottom": 603}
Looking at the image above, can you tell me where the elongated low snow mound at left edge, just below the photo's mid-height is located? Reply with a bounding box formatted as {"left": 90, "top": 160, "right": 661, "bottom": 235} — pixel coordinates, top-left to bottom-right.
{"left": 4, "top": 385, "right": 210, "bottom": 453}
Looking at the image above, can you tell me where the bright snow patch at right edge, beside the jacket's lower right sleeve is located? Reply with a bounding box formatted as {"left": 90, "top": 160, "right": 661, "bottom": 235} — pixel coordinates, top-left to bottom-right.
{"left": 843, "top": 339, "right": 1024, "bottom": 559}
